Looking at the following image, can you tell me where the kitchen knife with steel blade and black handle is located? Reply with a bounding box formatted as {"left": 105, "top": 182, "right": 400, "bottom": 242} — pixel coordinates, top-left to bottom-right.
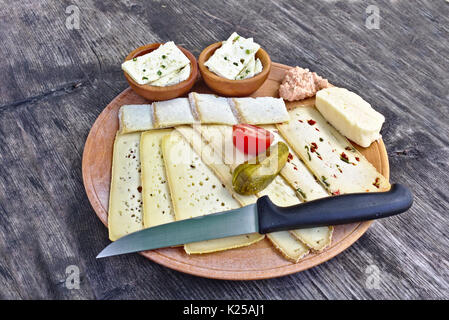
{"left": 97, "top": 184, "right": 413, "bottom": 258}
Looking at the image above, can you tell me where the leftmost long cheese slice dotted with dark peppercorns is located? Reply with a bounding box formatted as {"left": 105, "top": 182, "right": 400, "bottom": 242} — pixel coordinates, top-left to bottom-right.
{"left": 108, "top": 133, "right": 143, "bottom": 241}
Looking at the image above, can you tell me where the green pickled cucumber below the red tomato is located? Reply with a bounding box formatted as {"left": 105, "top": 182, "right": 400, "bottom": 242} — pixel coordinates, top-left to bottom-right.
{"left": 232, "top": 142, "right": 289, "bottom": 195}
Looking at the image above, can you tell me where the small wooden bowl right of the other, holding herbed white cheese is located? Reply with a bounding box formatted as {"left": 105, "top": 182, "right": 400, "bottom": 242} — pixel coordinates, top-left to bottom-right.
{"left": 198, "top": 42, "right": 271, "bottom": 97}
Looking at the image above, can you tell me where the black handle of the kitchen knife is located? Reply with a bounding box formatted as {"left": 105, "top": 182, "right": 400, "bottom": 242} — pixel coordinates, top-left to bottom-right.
{"left": 257, "top": 184, "right": 413, "bottom": 233}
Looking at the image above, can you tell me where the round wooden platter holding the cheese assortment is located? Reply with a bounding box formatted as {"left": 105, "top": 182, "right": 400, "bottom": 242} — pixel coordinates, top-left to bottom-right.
{"left": 82, "top": 63, "right": 389, "bottom": 280}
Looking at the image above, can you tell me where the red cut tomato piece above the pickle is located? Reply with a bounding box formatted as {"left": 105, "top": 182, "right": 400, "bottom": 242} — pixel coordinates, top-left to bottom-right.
{"left": 232, "top": 124, "right": 274, "bottom": 155}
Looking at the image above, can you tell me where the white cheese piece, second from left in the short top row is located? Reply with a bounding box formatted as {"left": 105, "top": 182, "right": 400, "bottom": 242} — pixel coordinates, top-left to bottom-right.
{"left": 153, "top": 98, "right": 195, "bottom": 128}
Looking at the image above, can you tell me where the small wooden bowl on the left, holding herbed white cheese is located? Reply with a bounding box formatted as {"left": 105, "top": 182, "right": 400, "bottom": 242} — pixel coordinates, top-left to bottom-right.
{"left": 123, "top": 43, "right": 198, "bottom": 101}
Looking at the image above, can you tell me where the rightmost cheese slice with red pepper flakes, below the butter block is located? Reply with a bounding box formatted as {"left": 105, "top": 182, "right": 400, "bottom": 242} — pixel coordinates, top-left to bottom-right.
{"left": 277, "top": 107, "right": 390, "bottom": 195}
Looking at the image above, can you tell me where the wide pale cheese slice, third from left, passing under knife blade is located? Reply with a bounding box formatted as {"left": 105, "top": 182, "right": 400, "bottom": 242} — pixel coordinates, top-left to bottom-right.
{"left": 162, "top": 132, "right": 262, "bottom": 254}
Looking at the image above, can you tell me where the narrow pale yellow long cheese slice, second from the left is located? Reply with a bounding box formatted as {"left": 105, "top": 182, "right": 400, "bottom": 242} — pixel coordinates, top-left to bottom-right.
{"left": 140, "top": 129, "right": 175, "bottom": 228}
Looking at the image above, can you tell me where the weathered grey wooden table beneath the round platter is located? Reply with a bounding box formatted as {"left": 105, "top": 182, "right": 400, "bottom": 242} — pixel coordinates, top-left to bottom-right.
{"left": 0, "top": 0, "right": 449, "bottom": 299}
